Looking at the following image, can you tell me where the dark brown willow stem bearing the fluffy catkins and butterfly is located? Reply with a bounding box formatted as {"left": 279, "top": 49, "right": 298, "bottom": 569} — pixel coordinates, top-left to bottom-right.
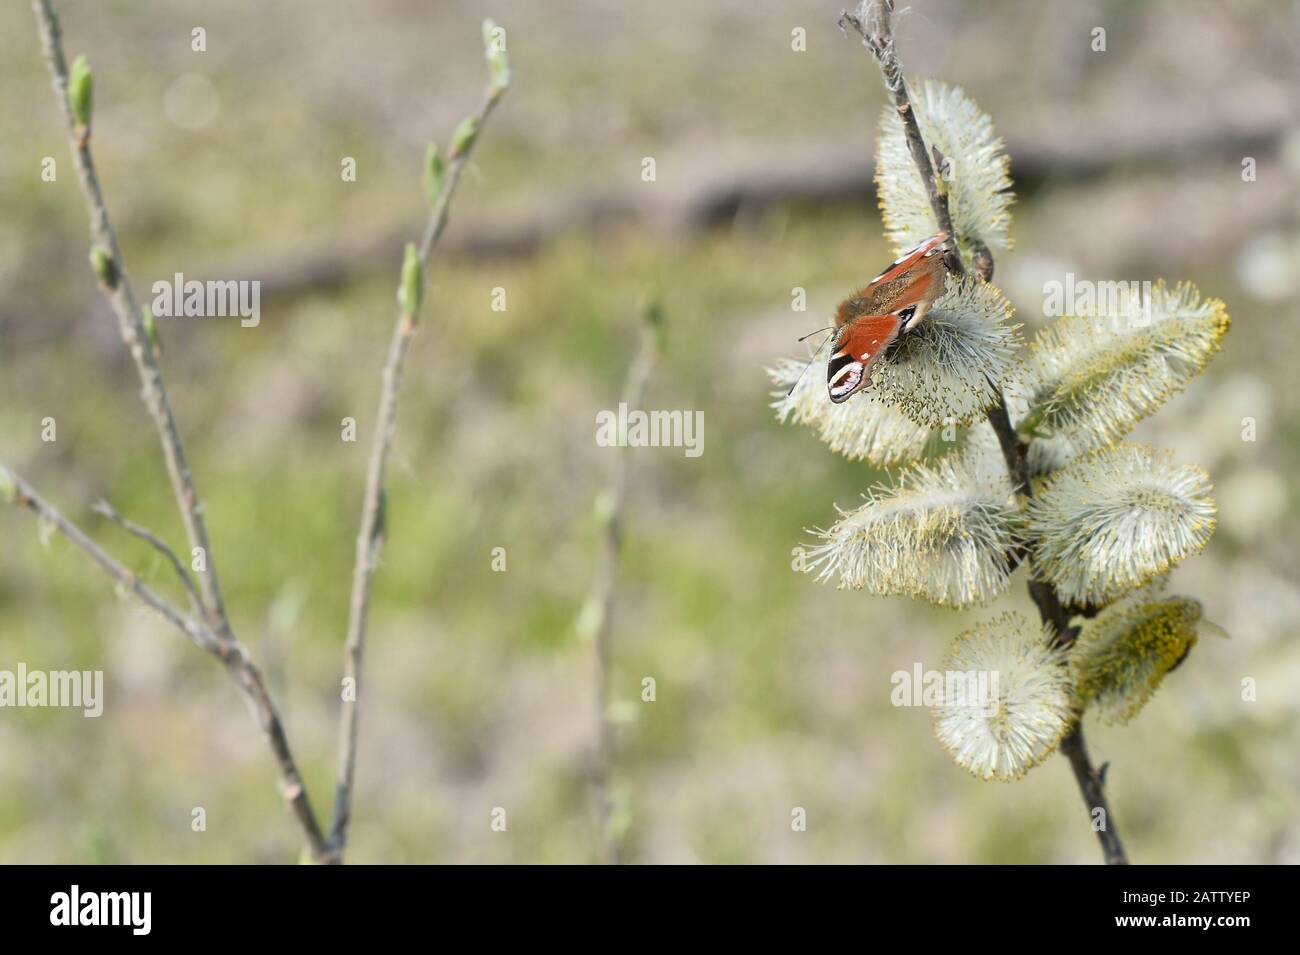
{"left": 840, "top": 0, "right": 1128, "bottom": 865}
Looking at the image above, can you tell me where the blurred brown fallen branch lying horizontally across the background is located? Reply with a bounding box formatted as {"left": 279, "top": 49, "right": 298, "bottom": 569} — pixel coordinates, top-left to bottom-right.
{"left": 144, "top": 123, "right": 1291, "bottom": 306}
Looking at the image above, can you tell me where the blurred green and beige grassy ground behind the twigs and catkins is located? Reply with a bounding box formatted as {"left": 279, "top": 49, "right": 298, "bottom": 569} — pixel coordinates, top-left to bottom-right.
{"left": 0, "top": 0, "right": 1300, "bottom": 863}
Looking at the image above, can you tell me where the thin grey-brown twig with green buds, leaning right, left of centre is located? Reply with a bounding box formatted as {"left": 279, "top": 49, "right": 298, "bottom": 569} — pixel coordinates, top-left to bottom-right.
{"left": 330, "top": 83, "right": 504, "bottom": 861}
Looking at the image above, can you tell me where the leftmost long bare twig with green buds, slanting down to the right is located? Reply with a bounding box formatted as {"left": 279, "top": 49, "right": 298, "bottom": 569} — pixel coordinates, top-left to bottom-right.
{"left": 31, "top": 0, "right": 328, "bottom": 861}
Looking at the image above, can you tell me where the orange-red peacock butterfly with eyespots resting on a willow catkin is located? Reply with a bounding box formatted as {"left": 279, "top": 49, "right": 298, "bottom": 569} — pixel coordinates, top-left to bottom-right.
{"left": 826, "top": 233, "right": 948, "bottom": 404}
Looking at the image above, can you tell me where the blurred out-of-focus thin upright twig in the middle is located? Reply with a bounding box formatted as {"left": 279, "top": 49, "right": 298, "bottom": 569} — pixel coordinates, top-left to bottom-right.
{"left": 588, "top": 300, "right": 662, "bottom": 864}
